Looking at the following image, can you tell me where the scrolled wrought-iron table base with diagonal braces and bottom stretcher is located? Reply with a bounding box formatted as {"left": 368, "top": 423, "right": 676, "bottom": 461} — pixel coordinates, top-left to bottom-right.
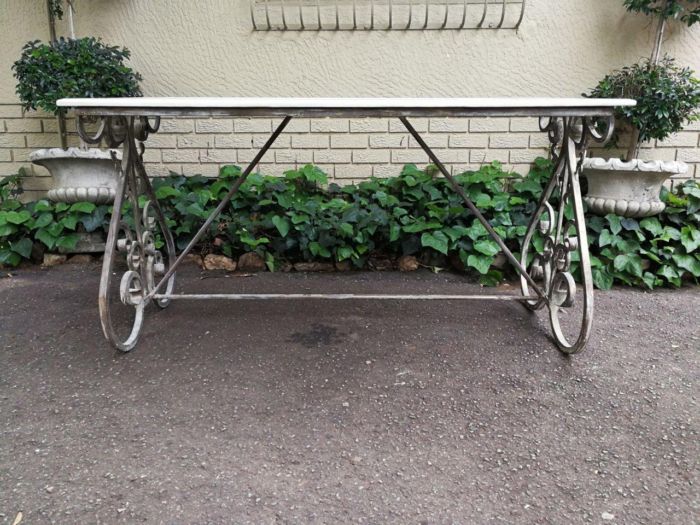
{"left": 79, "top": 115, "right": 613, "bottom": 354}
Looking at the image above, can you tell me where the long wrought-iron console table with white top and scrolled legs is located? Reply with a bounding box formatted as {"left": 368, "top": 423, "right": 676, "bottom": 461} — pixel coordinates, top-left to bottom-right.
{"left": 58, "top": 98, "right": 635, "bottom": 354}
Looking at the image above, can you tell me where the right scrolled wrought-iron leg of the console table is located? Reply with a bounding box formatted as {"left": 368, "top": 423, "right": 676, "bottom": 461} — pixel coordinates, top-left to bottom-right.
{"left": 520, "top": 117, "right": 614, "bottom": 354}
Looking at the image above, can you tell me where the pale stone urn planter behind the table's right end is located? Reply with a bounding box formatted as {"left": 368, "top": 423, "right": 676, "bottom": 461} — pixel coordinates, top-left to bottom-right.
{"left": 583, "top": 158, "right": 688, "bottom": 218}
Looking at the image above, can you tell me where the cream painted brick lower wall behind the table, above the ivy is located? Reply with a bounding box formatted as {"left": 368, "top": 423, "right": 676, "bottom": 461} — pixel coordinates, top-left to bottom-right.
{"left": 0, "top": 104, "right": 700, "bottom": 196}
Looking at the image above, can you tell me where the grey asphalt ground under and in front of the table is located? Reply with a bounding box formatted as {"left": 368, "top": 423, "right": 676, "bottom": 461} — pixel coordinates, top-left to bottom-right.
{"left": 0, "top": 265, "right": 700, "bottom": 524}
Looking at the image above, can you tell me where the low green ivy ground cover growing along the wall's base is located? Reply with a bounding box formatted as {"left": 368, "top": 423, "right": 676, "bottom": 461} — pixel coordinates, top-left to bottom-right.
{"left": 0, "top": 159, "right": 700, "bottom": 288}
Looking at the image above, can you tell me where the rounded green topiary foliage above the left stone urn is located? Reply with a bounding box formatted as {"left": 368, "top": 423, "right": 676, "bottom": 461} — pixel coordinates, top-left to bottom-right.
{"left": 12, "top": 37, "right": 141, "bottom": 113}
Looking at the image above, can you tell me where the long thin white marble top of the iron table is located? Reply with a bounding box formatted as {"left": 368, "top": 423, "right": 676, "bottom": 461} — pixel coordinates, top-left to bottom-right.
{"left": 57, "top": 97, "right": 636, "bottom": 116}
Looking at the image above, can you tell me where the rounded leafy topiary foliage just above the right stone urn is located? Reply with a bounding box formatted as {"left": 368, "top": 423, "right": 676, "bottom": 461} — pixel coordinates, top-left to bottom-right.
{"left": 589, "top": 57, "right": 700, "bottom": 147}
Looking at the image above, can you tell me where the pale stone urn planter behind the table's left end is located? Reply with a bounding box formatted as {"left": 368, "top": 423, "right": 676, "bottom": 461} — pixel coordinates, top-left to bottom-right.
{"left": 29, "top": 148, "right": 121, "bottom": 204}
